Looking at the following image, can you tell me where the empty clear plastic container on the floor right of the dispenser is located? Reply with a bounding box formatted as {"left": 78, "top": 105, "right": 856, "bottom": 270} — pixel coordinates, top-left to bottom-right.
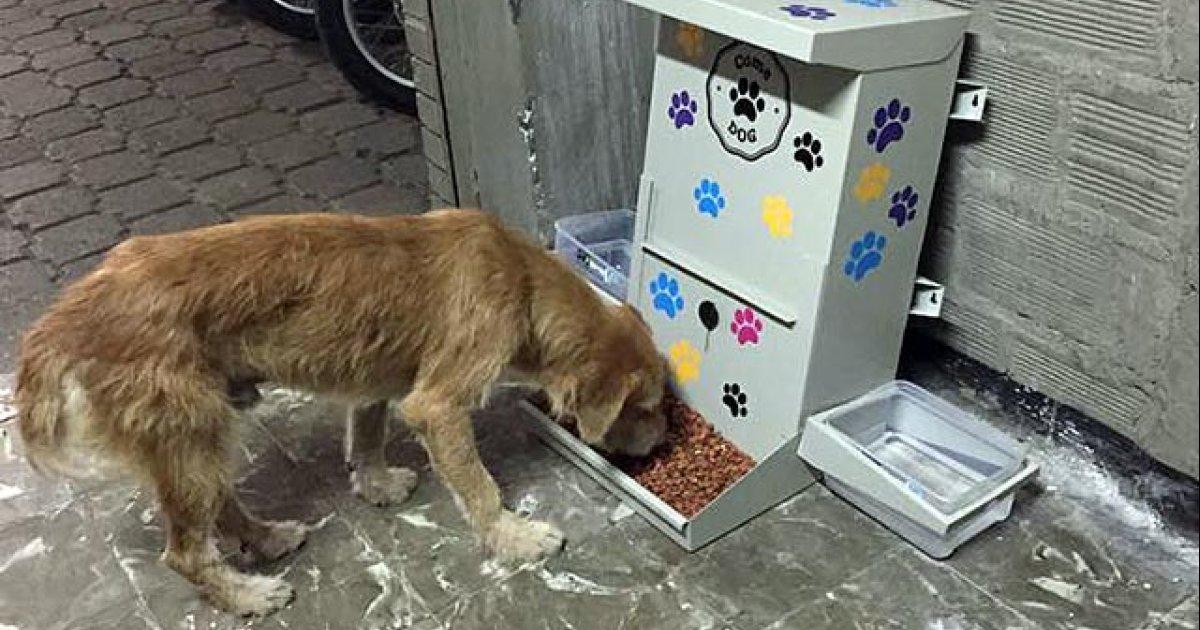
{"left": 799, "top": 380, "right": 1037, "bottom": 558}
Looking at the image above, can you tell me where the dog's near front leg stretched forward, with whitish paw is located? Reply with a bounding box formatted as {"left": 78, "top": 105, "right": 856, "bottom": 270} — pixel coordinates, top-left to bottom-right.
{"left": 401, "top": 389, "right": 564, "bottom": 560}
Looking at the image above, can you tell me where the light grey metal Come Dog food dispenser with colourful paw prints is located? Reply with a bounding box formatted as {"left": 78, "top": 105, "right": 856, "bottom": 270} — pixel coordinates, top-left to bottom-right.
{"left": 527, "top": 0, "right": 1041, "bottom": 550}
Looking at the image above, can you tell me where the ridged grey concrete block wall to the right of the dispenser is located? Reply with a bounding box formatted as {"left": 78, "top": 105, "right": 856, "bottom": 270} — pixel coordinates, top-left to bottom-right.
{"left": 923, "top": 0, "right": 1200, "bottom": 476}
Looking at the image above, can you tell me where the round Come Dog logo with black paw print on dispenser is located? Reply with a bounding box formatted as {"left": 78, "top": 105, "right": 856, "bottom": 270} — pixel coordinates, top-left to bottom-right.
{"left": 708, "top": 42, "right": 792, "bottom": 162}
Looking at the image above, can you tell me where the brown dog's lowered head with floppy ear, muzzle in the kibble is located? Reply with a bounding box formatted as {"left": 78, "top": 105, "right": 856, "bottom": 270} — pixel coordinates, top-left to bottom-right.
{"left": 547, "top": 306, "right": 667, "bottom": 456}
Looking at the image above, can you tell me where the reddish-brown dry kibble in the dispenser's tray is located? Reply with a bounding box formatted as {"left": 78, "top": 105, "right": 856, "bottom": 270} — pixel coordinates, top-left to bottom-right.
{"left": 610, "top": 395, "right": 755, "bottom": 518}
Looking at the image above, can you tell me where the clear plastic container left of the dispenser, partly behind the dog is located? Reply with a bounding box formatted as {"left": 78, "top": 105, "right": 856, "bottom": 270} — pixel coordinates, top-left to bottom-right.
{"left": 554, "top": 210, "right": 634, "bottom": 301}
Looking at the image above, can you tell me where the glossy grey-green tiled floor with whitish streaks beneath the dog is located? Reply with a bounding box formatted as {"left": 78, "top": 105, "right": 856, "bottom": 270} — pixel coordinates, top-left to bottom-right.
{"left": 0, "top": 352, "right": 1198, "bottom": 630}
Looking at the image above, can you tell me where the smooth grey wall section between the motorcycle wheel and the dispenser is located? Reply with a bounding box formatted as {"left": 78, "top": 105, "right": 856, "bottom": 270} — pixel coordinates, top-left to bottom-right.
{"left": 432, "top": 0, "right": 654, "bottom": 241}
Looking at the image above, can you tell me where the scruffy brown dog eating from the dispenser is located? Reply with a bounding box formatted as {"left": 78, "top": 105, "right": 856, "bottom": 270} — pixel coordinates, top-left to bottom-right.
{"left": 17, "top": 210, "right": 666, "bottom": 614}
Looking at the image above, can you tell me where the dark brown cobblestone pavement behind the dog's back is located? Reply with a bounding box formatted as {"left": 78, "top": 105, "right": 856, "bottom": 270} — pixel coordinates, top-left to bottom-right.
{"left": 0, "top": 0, "right": 427, "bottom": 373}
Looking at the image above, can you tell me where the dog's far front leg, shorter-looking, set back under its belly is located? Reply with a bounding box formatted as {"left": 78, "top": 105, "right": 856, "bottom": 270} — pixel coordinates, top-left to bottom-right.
{"left": 346, "top": 401, "right": 416, "bottom": 506}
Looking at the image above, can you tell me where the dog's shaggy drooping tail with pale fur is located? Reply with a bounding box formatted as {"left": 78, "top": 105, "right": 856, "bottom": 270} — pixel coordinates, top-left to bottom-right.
{"left": 14, "top": 338, "right": 103, "bottom": 476}
